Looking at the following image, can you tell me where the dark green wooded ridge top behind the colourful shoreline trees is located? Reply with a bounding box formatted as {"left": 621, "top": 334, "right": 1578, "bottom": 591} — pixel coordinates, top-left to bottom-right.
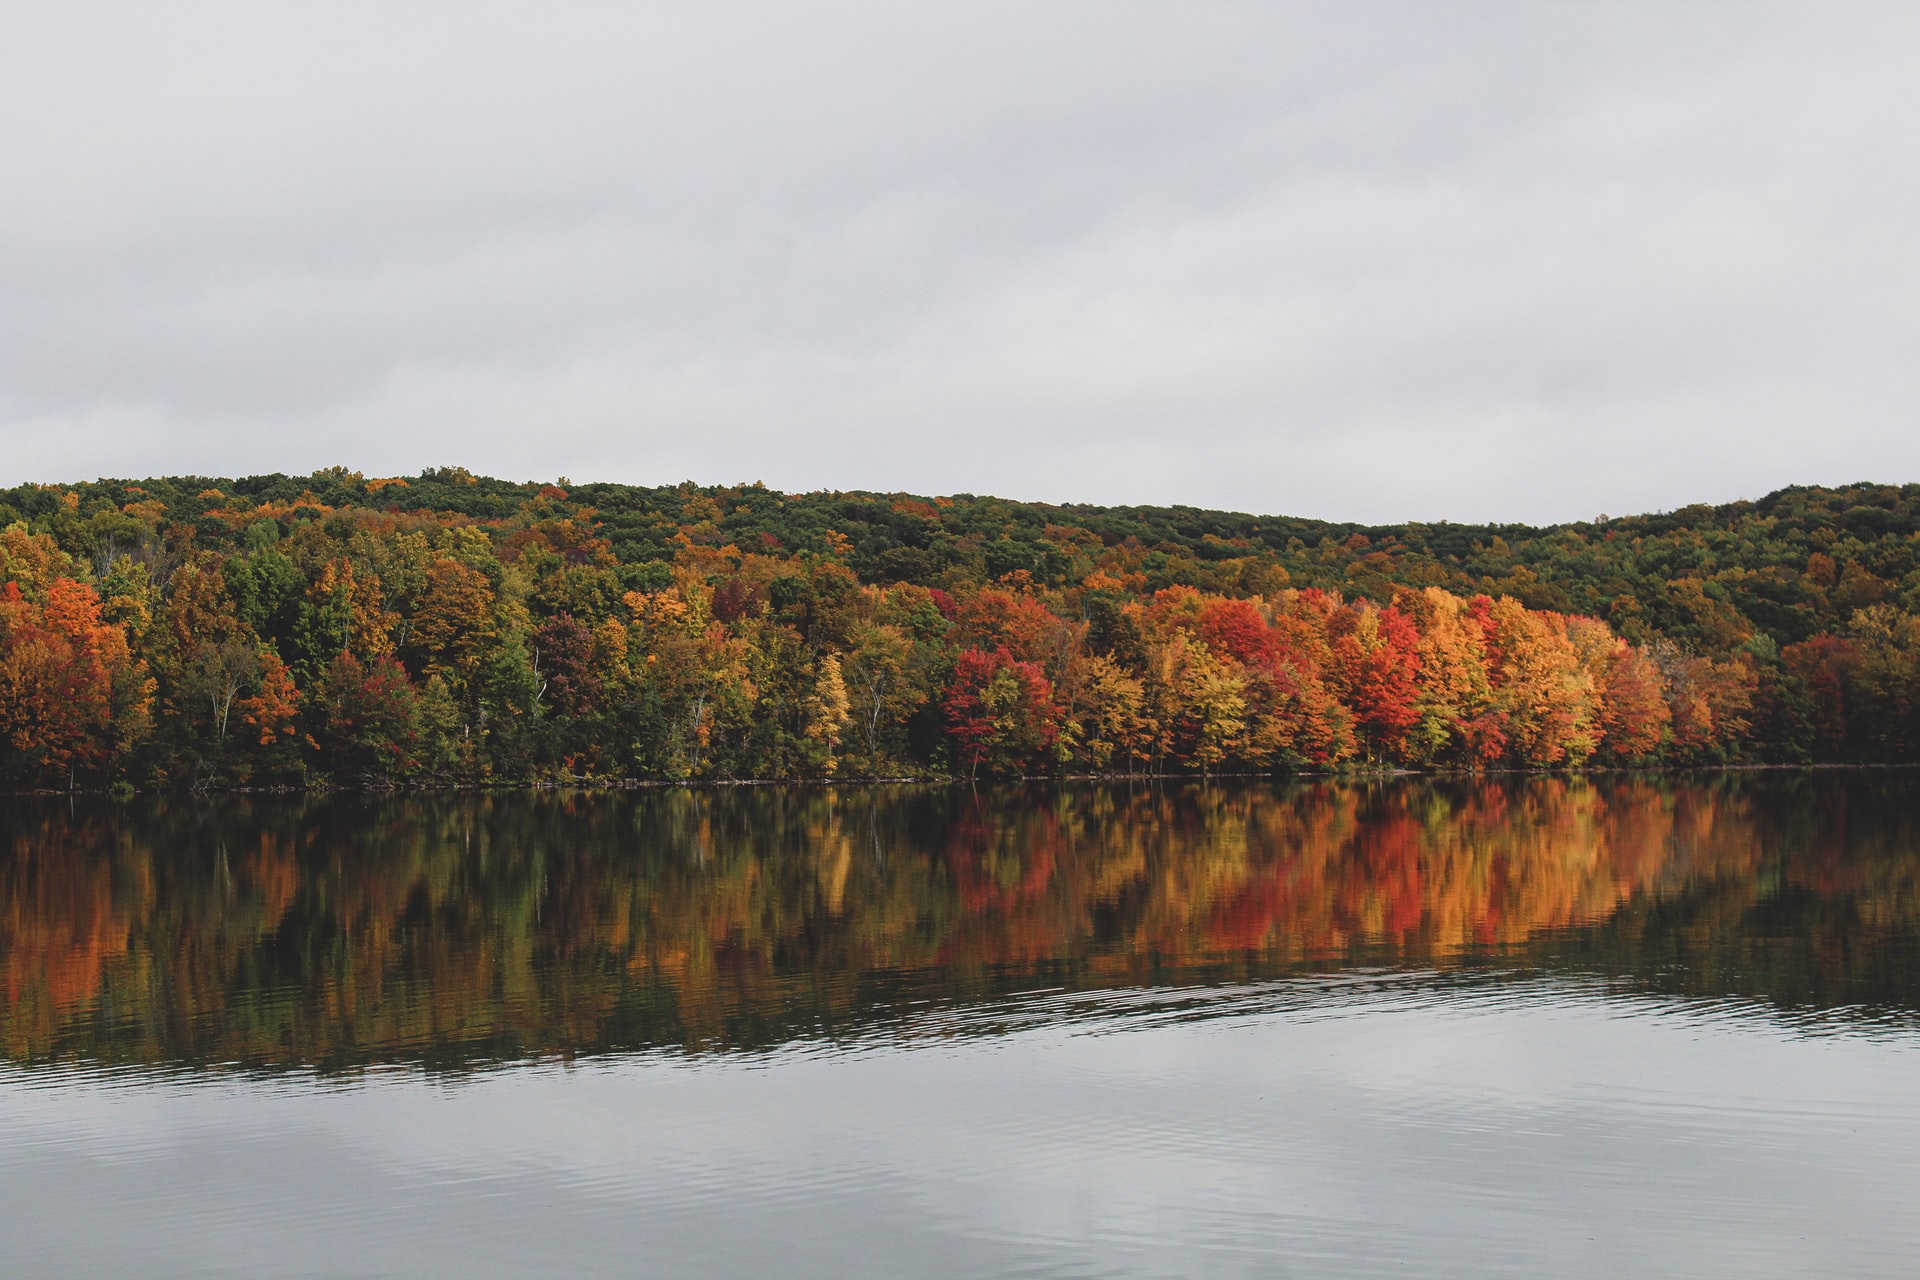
{"left": 18, "top": 468, "right": 1920, "bottom": 649}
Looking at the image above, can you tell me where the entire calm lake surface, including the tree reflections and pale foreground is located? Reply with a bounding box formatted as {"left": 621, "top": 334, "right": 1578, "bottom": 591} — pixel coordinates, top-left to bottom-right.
{"left": 0, "top": 771, "right": 1920, "bottom": 1276}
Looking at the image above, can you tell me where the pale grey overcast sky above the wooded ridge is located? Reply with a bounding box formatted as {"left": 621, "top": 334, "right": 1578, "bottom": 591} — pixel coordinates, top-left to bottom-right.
{"left": 0, "top": 0, "right": 1920, "bottom": 522}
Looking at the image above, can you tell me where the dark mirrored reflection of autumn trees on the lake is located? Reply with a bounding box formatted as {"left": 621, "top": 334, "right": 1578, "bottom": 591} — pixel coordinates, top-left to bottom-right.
{"left": 0, "top": 773, "right": 1920, "bottom": 1065}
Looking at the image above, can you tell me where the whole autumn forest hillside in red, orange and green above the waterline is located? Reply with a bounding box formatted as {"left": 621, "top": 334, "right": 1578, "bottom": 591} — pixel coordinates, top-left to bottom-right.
{"left": 0, "top": 468, "right": 1920, "bottom": 789}
